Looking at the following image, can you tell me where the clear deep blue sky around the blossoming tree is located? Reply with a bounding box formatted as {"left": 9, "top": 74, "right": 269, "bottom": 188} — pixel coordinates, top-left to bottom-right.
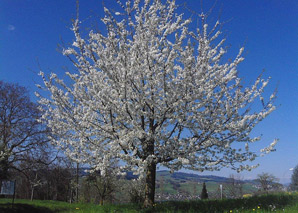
{"left": 0, "top": 0, "right": 298, "bottom": 182}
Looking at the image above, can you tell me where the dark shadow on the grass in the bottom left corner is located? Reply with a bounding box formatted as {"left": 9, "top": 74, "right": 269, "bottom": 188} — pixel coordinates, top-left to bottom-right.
{"left": 0, "top": 203, "right": 57, "bottom": 213}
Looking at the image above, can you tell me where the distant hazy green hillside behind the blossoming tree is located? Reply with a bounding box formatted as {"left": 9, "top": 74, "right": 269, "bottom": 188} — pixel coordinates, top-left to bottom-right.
{"left": 72, "top": 167, "right": 282, "bottom": 200}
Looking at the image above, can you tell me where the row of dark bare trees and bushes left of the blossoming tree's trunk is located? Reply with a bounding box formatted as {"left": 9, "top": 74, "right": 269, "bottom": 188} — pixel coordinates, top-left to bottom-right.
{"left": 12, "top": 159, "right": 144, "bottom": 205}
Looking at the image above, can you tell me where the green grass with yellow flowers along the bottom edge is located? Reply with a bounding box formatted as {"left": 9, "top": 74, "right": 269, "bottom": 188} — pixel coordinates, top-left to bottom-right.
{"left": 0, "top": 193, "right": 298, "bottom": 213}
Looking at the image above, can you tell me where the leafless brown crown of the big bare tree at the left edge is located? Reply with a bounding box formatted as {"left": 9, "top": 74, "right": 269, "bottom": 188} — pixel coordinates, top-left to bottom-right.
{"left": 0, "top": 81, "right": 49, "bottom": 181}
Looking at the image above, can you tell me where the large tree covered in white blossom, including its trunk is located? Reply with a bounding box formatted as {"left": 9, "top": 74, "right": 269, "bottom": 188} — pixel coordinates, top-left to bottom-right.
{"left": 37, "top": 0, "right": 276, "bottom": 206}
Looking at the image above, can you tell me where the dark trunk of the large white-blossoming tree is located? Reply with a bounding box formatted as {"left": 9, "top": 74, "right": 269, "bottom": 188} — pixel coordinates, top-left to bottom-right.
{"left": 144, "top": 163, "right": 156, "bottom": 208}
